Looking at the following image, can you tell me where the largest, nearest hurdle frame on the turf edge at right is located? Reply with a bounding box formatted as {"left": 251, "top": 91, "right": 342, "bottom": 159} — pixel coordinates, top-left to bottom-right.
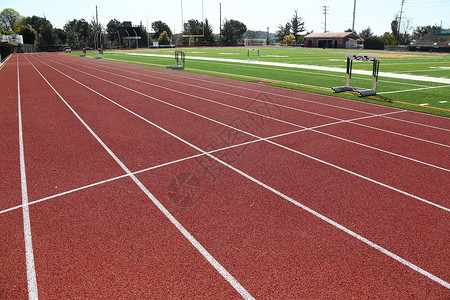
{"left": 332, "top": 54, "right": 380, "bottom": 97}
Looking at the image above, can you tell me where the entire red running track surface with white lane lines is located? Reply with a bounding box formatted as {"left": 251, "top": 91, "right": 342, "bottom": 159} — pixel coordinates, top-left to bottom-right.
{"left": 0, "top": 54, "right": 450, "bottom": 299}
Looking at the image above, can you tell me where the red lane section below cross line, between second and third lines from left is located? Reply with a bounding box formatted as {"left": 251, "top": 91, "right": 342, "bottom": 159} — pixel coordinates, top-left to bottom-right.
{"left": 134, "top": 157, "right": 448, "bottom": 299}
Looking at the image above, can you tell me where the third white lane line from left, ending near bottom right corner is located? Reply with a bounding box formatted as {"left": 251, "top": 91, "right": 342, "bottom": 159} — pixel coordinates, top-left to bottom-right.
{"left": 30, "top": 54, "right": 450, "bottom": 289}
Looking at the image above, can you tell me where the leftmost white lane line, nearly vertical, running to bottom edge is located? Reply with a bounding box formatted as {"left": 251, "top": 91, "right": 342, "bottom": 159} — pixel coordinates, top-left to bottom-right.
{"left": 16, "top": 56, "right": 38, "bottom": 299}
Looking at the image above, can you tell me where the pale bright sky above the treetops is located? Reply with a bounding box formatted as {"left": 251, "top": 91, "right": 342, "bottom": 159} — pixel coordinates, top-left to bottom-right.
{"left": 0, "top": 0, "right": 450, "bottom": 35}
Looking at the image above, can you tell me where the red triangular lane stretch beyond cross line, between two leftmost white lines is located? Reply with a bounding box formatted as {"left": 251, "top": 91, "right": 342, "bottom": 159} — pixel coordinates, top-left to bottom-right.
{"left": 16, "top": 56, "right": 123, "bottom": 201}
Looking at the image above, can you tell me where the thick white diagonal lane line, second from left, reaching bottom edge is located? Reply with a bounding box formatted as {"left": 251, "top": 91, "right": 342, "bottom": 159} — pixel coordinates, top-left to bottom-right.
{"left": 27, "top": 59, "right": 254, "bottom": 299}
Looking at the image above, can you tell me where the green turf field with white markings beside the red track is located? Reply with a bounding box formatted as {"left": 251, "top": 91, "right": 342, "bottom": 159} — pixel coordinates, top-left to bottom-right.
{"left": 67, "top": 47, "right": 450, "bottom": 117}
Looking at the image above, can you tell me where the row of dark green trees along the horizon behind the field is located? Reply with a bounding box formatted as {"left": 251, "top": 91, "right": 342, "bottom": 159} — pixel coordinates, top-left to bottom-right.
{"left": 0, "top": 8, "right": 441, "bottom": 50}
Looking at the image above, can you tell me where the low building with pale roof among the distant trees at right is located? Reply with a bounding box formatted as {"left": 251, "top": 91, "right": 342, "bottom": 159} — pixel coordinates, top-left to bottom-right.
{"left": 305, "top": 32, "right": 364, "bottom": 49}
